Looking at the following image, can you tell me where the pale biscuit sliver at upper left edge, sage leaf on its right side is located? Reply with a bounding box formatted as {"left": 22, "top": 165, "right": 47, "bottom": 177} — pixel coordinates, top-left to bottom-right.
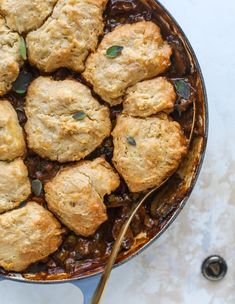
{"left": 0, "top": 16, "right": 22, "bottom": 96}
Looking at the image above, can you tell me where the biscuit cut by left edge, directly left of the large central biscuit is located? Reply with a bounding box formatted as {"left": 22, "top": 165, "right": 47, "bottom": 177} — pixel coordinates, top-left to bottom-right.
{"left": 0, "top": 100, "right": 25, "bottom": 161}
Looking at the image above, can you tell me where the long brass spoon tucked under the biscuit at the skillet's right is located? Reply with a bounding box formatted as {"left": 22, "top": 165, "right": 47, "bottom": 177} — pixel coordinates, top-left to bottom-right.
{"left": 91, "top": 96, "right": 196, "bottom": 304}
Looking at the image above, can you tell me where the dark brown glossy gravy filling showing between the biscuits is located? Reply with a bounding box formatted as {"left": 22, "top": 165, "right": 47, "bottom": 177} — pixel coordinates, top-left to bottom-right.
{"left": 0, "top": 0, "right": 201, "bottom": 280}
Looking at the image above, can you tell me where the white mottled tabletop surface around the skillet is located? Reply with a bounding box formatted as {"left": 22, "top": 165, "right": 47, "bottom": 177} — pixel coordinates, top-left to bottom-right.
{"left": 0, "top": 0, "right": 235, "bottom": 304}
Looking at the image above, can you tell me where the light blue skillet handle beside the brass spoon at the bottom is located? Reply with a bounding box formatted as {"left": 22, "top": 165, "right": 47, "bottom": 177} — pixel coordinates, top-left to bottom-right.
{"left": 72, "top": 275, "right": 101, "bottom": 304}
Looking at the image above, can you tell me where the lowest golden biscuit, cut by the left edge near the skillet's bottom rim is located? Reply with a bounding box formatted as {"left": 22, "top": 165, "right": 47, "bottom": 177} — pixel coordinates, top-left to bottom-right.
{"left": 0, "top": 202, "right": 63, "bottom": 272}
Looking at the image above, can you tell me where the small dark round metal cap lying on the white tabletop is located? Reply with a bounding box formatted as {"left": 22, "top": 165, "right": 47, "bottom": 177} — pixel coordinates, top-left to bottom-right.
{"left": 202, "top": 255, "right": 228, "bottom": 281}
